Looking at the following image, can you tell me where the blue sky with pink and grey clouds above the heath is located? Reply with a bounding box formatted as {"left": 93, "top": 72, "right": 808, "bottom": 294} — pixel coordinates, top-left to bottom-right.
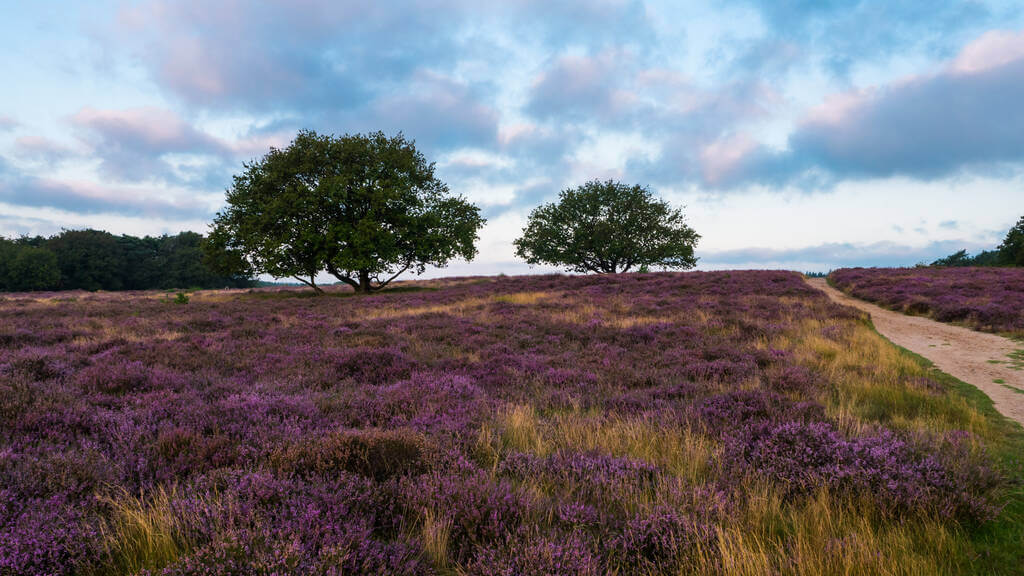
{"left": 0, "top": 0, "right": 1024, "bottom": 276}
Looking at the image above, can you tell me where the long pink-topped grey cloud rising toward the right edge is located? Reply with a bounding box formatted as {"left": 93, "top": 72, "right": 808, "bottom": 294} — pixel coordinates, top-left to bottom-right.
{"left": 706, "top": 33, "right": 1024, "bottom": 188}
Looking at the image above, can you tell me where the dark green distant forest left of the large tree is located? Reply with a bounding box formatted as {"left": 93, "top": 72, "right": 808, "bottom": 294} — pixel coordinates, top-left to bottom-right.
{"left": 0, "top": 230, "right": 254, "bottom": 292}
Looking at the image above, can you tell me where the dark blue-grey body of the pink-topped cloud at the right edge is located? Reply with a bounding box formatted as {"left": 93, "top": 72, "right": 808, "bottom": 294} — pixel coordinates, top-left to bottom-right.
{"left": 790, "top": 59, "right": 1024, "bottom": 178}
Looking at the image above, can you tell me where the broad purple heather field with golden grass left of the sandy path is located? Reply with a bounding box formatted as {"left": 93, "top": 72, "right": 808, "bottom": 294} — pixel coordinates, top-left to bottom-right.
{"left": 0, "top": 272, "right": 1022, "bottom": 576}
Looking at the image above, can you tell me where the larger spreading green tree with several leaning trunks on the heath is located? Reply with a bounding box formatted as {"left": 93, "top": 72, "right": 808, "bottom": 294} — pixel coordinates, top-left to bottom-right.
{"left": 207, "top": 130, "right": 483, "bottom": 292}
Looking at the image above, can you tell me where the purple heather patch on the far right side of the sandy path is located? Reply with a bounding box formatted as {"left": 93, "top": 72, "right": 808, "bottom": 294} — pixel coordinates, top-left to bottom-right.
{"left": 828, "top": 268, "right": 1024, "bottom": 337}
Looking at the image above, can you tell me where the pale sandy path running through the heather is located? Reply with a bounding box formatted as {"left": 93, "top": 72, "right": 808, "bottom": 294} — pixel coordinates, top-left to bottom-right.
{"left": 807, "top": 278, "right": 1024, "bottom": 424}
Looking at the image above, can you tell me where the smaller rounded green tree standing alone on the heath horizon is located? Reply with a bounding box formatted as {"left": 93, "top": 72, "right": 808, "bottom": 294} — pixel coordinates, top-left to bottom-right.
{"left": 515, "top": 180, "right": 700, "bottom": 273}
